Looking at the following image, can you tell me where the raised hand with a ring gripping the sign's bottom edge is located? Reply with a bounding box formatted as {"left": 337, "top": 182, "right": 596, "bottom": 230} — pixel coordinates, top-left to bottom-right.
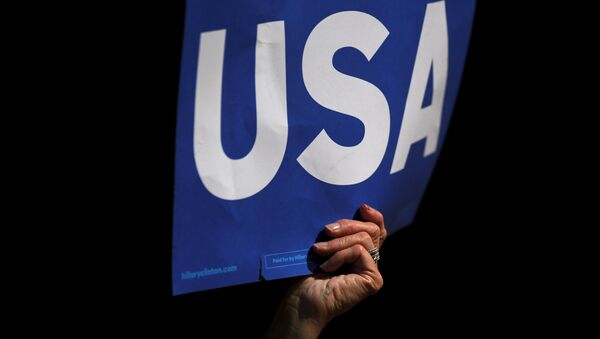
{"left": 266, "top": 204, "right": 386, "bottom": 338}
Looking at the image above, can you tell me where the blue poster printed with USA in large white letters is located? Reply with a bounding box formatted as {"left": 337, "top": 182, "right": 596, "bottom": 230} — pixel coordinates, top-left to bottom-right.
{"left": 173, "top": 0, "right": 475, "bottom": 295}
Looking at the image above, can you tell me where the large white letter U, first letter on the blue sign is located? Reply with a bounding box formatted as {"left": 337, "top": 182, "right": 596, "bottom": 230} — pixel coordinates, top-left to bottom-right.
{"left": 194, "top": 21, "right": 288, "bottom": 200}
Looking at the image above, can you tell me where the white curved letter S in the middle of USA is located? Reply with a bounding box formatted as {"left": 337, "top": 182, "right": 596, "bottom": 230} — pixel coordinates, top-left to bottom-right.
{"left": 297, "top": 11, "right": 390, "bottom": 185}
